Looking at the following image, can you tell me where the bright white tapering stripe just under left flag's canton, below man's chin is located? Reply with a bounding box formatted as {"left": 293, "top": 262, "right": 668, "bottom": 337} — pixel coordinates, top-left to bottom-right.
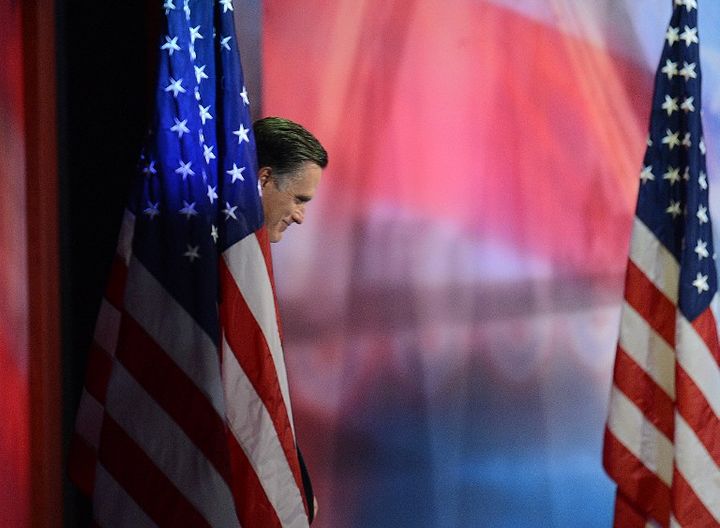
{"left": 223, "top": 234, "right": 295, "bottom": 437}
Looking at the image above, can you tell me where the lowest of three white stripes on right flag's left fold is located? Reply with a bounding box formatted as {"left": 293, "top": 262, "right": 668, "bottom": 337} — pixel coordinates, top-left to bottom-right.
{"left": 607, "top": 385, "right": 673, "bottom": 486}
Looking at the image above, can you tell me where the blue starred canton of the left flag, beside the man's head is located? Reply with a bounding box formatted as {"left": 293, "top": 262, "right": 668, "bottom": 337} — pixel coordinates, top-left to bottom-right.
{"left": 129, "top": 0, "right": 263, "bottom": 343}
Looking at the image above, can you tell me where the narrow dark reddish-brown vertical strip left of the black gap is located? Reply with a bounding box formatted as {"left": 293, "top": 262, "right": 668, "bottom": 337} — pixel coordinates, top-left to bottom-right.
{"left": 22, "top": 0, "right": 62, "bottom": 527}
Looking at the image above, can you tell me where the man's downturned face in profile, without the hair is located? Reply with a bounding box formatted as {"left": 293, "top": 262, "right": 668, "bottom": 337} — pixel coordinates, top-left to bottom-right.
{"left": 259, "top": 161, "right": 322, "bottom": 242}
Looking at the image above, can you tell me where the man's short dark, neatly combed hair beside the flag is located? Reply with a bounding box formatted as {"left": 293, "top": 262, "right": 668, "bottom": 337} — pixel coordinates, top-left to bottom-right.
{"left": 253, "top": 117, "right": 328, "bottom": 181}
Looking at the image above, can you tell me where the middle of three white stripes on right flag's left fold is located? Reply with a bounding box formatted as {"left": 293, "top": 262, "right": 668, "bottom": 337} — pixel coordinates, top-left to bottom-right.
{"left": 619, "top": 301, "right": 675, "bottom": 400}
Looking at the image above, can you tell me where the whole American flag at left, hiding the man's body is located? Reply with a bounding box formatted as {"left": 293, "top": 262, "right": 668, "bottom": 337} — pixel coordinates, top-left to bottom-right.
{"left": 70, "top": 0, "right": 309, "bottom": 527}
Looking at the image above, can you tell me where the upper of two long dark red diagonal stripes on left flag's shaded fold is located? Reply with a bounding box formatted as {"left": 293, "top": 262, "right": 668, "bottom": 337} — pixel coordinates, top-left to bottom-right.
{"left": 117, "top": 313, "right": 232, "bottom": 484}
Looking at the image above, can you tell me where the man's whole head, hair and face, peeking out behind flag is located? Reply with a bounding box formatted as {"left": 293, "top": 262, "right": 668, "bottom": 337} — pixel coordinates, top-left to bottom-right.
{"left": 253, "top": 117, "right": 328, "bottom": 242}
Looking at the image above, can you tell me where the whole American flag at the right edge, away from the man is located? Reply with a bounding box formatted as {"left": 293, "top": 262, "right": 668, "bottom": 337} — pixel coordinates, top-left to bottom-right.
{"left": 603, "top": 0, "right": 720, "bottom": 527}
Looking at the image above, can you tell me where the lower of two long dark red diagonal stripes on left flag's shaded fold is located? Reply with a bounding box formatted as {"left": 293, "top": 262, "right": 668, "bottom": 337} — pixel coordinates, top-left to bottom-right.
{"left": 99, "top": 414, "right": 210, "bottom": 528}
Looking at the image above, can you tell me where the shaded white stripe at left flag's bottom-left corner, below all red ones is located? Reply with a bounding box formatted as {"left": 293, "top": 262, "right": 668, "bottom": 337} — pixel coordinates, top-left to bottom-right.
{"left": 93, "top": 464, "right": 157, "bottom": 528}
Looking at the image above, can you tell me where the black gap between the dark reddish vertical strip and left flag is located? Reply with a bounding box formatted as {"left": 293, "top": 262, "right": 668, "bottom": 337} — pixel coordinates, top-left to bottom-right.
{"left": 57, "top": 0, "right": 161, "bottom": 527}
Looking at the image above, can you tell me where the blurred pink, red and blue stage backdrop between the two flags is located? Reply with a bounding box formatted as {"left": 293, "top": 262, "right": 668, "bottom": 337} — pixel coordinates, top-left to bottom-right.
{"left": 263, "top": 0, "right": 720, "bottom": 528}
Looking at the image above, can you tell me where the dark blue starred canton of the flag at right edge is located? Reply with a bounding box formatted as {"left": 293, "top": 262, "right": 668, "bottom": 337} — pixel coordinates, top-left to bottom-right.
{"left": 637, "top": 0, "right": 717, "bottom": 321}
